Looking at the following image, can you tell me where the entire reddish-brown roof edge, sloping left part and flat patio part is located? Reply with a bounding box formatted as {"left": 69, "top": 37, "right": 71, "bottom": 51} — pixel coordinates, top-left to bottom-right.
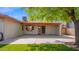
{"left": 0, "top": 14, "right": 61, "bottom": 26}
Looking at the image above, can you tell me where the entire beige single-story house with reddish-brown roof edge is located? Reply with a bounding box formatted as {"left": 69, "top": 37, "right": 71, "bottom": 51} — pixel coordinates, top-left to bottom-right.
{"left": 0, "top": 14, "right": 61, "bottom": 39}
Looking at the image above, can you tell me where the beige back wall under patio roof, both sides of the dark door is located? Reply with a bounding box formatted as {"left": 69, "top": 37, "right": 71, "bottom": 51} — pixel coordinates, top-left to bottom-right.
{"left": 24, "top": 26, "right": 61, "bottom": 35}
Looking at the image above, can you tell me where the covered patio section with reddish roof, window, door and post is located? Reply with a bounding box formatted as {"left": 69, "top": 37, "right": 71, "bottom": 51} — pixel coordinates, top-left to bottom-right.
{"left": 21, "top": 22, "right": 62, "bottom": 36}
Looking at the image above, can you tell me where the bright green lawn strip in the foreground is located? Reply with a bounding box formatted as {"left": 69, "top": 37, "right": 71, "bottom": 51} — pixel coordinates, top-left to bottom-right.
{"left": 0, "top": 44, "right": 77, "bottom": 51}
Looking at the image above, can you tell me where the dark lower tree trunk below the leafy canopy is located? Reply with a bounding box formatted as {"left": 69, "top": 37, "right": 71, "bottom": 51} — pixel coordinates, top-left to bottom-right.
{"left": 74, "top": 20, "right": 79, "bottom": 46}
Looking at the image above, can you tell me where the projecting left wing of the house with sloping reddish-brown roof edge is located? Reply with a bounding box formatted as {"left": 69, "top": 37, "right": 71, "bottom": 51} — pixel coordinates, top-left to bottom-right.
{"left": 0, "top": 14, "right": 22, "bottom": 39}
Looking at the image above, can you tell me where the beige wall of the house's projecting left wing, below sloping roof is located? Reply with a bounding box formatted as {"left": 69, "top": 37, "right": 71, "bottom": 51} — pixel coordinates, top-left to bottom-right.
{"left": 4, "top": 20, "right": 22, "bottom": 39}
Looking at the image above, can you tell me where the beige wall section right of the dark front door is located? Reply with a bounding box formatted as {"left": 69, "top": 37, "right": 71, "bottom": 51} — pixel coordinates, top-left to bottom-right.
{"left": 45, "top": 26, "right": 60, "bottom": 35}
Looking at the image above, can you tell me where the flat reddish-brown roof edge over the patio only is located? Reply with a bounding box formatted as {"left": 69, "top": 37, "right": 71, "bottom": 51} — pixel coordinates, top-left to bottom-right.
{"left": 21, "top": 22, "right": 61, "bottom": 26}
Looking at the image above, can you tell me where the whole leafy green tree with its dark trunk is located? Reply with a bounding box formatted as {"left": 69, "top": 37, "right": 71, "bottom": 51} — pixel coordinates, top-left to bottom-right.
{"left": 24, "top": 7, "right": 79, "bottom": 46}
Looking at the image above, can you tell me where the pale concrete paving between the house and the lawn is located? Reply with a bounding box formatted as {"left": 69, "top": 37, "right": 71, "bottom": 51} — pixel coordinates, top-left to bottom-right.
{"left": 0, "top": 35, "right": 75, "bottom": 44}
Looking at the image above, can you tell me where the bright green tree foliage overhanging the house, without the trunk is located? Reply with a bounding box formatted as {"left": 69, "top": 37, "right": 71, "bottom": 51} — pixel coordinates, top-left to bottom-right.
{"left": 24, "top": 7, "right": 79, "bottom": 22}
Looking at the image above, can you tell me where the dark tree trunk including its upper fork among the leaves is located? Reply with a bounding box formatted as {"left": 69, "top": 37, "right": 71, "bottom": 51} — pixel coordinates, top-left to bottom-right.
{"left": 67, "top": 9, "right": 79, "bottom": 47}
